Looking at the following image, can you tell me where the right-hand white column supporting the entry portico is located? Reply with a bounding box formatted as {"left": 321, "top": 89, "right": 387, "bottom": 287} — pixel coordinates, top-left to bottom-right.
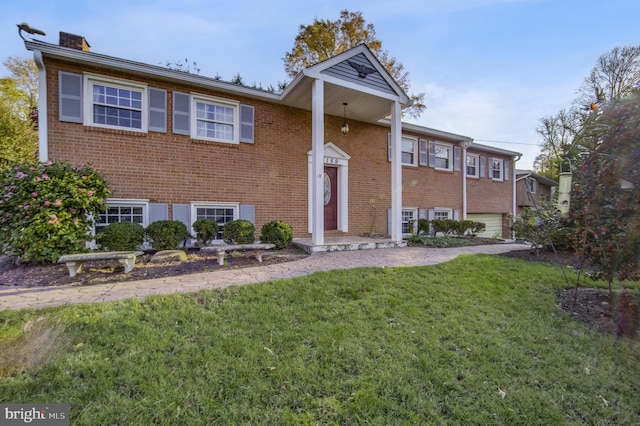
{"left": 391, "top": 101, "right": 402, "bottom": 241}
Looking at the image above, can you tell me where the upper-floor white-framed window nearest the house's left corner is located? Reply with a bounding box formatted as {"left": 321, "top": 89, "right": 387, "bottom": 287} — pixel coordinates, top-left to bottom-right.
{"left": 84, "top": 75, "right": 148, "bottom": 132}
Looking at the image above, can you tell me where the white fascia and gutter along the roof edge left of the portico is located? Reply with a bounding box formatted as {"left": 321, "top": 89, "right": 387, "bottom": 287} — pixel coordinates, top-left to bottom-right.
{"left": 25, "top": 41, "right": 281, "bottom": 101}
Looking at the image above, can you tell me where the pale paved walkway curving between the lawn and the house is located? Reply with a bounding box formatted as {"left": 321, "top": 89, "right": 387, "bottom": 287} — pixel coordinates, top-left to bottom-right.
{"left": 0, "top": 243, "right": 530, "bottom": 310}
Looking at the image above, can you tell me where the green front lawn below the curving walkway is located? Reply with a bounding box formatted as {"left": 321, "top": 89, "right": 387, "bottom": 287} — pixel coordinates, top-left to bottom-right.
{"left": 0, "top": 255, "right": 640, "bottom": 425}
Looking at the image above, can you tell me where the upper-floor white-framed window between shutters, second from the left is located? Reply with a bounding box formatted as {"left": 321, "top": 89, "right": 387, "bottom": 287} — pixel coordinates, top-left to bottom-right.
{"left": 191, "top": 95, "right": 240, "bottom": 143}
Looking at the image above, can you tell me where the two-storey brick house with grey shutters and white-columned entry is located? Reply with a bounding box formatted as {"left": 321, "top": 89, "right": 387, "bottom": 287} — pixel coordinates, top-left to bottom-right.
{"left": 25, "top": 33, "right": 520, "bottom": 245}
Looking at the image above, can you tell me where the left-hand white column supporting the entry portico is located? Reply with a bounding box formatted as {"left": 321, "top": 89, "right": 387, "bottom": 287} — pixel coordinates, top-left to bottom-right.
{"left": 309, "top": 80, "right": 324, "bottom": 246}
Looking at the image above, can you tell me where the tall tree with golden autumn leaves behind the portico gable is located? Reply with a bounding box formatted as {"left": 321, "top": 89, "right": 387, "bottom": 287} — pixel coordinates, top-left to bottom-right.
{"left": 283, "top": 10, "right": 426, "bottom": 118}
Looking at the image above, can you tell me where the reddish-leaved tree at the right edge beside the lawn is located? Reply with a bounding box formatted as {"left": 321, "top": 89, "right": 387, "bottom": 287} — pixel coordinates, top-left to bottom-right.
{"left": 571, "top": 89, "right": 640, "bottom": 289}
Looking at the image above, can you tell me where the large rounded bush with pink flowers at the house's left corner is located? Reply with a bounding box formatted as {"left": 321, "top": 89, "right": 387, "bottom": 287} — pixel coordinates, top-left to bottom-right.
{"left": 0, "top": 162, "right": 110, "bottom": 262}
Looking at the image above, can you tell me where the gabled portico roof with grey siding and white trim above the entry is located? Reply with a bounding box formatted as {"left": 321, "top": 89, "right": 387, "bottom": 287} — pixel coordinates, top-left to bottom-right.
{"left": 282, "top": 44, "right": 411, "bottom": 123}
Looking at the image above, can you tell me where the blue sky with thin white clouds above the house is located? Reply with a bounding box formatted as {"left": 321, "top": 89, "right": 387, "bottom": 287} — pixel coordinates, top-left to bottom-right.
{"left": 0, "top": 0, "right": 640, "bottom": 168}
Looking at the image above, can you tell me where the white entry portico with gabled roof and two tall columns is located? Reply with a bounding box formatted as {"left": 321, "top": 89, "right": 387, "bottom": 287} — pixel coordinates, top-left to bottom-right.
{"left": 282, "top": 44, "right": 411, "bottom": 245}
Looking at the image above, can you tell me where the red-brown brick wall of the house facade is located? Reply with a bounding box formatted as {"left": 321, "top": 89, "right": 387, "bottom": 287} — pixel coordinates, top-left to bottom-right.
{"left": 45, "top": 58, "right": 511, "bottom": 237}
